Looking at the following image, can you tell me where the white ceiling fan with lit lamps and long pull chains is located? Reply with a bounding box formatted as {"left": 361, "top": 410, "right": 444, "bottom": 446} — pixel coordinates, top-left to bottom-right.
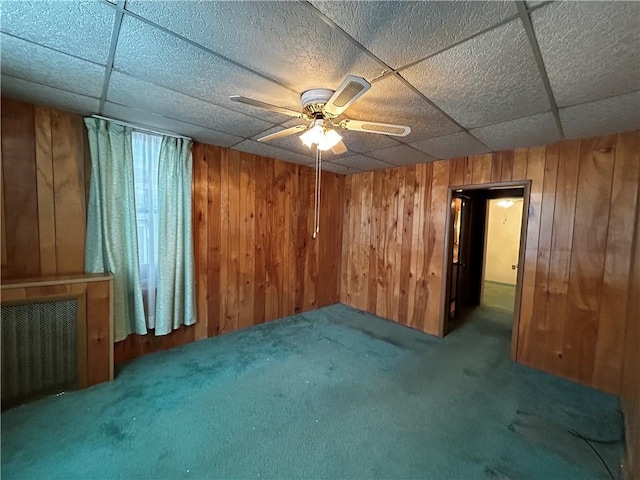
{"left": 230, "top": 75, "right": 411, "bottom": 238}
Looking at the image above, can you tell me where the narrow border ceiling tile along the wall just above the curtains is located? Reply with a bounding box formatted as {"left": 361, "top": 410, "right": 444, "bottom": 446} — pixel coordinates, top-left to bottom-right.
{"left": 104, "top": 102, "right": 243, "bottom": 147}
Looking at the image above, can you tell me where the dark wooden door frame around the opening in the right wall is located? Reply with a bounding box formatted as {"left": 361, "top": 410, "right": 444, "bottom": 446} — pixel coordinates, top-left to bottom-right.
{"left": 438, "top": 180, "right": 531, "bottom": 361}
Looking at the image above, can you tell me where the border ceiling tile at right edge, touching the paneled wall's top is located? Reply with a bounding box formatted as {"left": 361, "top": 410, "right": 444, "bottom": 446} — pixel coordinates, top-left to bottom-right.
{"left": 560, "top": 92, "right": 640, "bottom": 138}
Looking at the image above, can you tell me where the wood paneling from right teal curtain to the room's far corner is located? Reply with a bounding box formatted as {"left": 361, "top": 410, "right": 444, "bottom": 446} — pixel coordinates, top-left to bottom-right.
{"left": 115, "top": 143, "right": 344, "bottom": 362}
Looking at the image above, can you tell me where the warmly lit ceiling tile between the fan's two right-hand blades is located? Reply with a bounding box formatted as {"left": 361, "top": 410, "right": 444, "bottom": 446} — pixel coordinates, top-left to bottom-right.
{"left": 345, "top": 75, "right": 460, "bottom": 143}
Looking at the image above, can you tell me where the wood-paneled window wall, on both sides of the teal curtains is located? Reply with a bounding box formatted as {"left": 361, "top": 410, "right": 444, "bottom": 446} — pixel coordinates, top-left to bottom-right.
{"left": 0, "top": 98, "right": 344, "bottom": 363}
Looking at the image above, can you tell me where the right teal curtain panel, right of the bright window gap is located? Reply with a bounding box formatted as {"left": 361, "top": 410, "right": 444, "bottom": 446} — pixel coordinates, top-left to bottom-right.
{"left": 155, "top": 137, "right": 196, "bottom": 335}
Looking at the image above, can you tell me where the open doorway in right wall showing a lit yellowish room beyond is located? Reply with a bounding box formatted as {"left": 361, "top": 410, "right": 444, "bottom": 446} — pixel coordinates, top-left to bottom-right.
{"left": 442, "top": 182, "right": 530, "bottom": 358}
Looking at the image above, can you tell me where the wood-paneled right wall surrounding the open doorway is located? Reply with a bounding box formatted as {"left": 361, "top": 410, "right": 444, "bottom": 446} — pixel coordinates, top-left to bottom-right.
{"left": 340, "top": 132, "right": 640, "bottom": 393}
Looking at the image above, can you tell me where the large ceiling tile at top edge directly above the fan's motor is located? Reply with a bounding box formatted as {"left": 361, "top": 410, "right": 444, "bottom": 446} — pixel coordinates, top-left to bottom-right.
{"left": 127, "top": 0, "right": 384, "bottom": 92}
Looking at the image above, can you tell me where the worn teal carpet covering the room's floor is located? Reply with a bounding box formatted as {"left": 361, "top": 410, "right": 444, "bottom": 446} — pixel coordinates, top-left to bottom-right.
{"left": 2, "top": 305, "right": 623, "bottom": 479}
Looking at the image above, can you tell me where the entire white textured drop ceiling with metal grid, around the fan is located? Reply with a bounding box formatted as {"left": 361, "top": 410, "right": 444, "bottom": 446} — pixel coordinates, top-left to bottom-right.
{"left": 0, "top": 0, "right": 640, "bottom": 174}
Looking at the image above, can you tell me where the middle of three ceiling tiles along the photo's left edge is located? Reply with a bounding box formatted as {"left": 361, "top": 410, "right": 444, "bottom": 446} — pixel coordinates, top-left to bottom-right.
{"left": 0, "top": 34, "right": 105, "bottom": 98}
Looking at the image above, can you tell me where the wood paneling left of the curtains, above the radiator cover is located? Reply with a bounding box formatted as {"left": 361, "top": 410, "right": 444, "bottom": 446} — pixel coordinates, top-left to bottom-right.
{"left": 0, "top": 98, "right": 90, "bottom": 278}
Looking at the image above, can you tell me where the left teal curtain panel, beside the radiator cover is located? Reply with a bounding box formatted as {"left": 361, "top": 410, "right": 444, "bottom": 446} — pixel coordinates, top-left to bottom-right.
{"left": 84, "top": 118, "right": 147, "bottom": 341}
